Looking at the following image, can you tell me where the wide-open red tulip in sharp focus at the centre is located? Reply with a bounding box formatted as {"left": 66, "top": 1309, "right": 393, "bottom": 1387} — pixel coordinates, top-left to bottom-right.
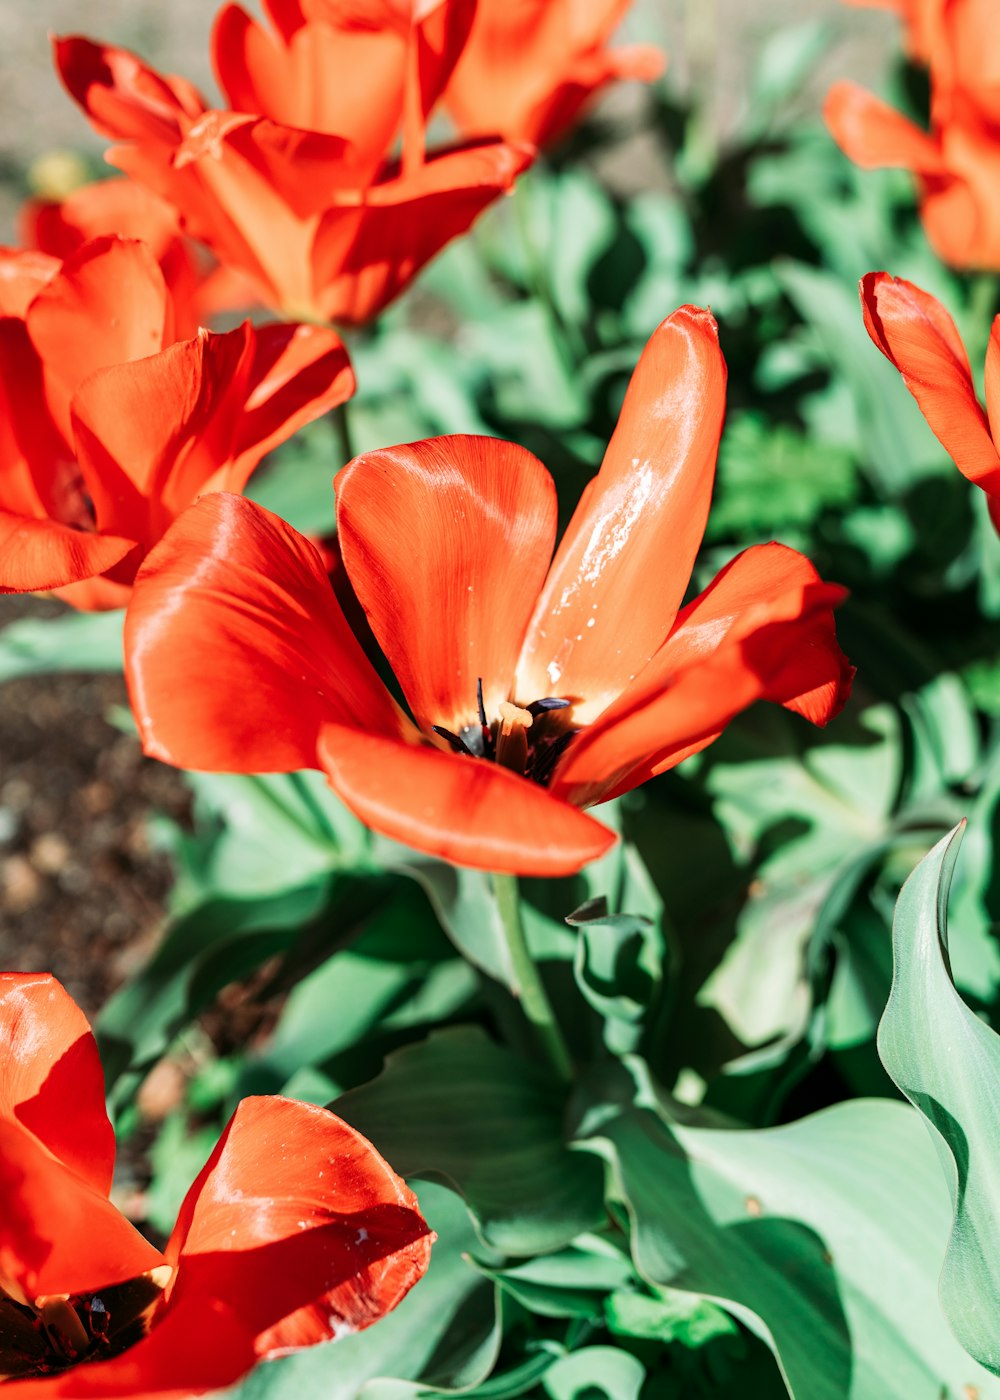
{"left": 126, "top": 307, "right": 850, "bottom": 875}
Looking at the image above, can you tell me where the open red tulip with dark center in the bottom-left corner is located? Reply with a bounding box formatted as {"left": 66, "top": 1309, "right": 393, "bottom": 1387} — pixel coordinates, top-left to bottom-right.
{"left": 0, "top": 973, "right": 433, "bottom": 1400}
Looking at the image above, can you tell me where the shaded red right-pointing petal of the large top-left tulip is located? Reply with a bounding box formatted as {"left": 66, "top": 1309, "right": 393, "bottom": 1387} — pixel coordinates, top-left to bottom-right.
{"left": 312, "top": 141, "right": 535, "bottom": 325}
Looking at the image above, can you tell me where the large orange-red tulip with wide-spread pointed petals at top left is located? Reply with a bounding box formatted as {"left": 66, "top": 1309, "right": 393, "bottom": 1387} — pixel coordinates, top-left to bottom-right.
{"left": 55, "top": 0, "right": 532, "bottom": 325}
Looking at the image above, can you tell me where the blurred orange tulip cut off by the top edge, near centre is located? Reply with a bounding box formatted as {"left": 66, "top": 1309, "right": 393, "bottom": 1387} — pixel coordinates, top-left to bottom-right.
{"left": 445, "top": 0, "right": 664, "bottom": 146}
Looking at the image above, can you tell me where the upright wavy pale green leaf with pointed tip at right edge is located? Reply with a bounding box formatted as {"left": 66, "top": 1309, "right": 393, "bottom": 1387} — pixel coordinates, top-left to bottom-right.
{"left": 878, "top": 826, "right": 1000, "bottom": 1373}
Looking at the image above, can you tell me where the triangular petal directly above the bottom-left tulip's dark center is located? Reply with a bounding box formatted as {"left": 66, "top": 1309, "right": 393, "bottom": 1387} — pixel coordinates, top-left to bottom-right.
{"left": 0, "top": 1119, "right": 162, "bottom": 1299}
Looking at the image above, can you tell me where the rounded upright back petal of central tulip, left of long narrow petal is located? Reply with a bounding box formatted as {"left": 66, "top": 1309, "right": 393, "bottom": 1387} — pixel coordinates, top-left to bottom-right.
{"left": 336, "top": 435, "right": 556, "bottom": 732}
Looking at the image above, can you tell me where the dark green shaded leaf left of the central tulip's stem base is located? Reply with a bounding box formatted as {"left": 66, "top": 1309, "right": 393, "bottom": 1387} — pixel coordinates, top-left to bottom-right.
{"left": 332, "top": 1028, "right": 604, "bottom": 1254}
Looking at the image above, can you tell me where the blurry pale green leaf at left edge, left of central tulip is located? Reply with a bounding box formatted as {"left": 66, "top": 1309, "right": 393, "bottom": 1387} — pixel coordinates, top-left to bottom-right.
{"left": 0, "top": 610, "right": 125, "bottom": 682}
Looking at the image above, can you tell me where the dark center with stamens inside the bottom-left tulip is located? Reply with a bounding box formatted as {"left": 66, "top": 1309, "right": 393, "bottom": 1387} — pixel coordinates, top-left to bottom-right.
{"left": 0, "top": 1264, "right": 172, "bottom": 1385}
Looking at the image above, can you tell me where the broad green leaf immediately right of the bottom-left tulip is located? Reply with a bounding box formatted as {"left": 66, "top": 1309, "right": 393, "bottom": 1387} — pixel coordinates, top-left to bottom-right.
{"left": 230, "top": 1181, "right": 500, "bottom": 1400}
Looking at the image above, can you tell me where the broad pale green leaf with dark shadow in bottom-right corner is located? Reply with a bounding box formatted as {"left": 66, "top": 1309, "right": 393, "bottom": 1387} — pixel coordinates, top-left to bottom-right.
{"left": 591, "top": 1071, "right": 1000, "bottom": 1400}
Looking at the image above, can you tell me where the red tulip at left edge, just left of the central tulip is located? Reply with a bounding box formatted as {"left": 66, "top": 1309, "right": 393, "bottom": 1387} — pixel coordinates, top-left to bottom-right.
{"left": 0, "top": 238, "right": 354, "bottom": 609}
